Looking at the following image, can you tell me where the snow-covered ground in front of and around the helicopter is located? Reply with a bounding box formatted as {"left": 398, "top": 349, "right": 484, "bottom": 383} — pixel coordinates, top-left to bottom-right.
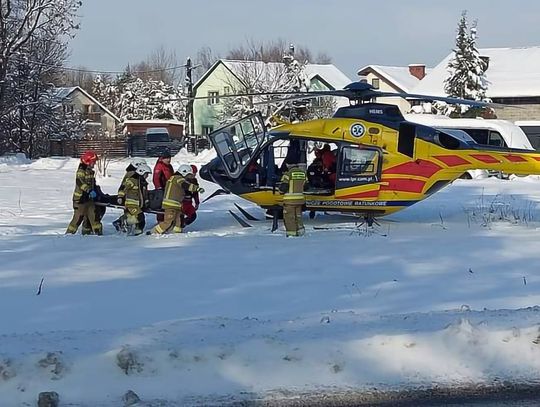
{"left": 0, "top": 151, "right": 540, "bottom": 406}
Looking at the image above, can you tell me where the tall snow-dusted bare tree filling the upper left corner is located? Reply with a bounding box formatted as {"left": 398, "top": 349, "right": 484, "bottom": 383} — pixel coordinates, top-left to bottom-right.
{"left": 0, "top": 0, "right": 80, "bottom": 157}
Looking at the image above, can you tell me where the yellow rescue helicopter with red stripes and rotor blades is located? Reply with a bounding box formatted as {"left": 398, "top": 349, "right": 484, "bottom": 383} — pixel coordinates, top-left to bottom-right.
{"left": 200, "top": 82, "right": 540, "bottom": 226}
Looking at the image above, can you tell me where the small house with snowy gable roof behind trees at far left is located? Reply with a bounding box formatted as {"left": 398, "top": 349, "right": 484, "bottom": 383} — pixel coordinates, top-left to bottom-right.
{"left": 53, "top": 86, "right": 120, "bottom": 135}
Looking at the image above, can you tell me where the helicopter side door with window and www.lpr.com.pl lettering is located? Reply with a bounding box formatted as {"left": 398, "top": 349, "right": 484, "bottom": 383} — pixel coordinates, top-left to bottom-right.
{"left": 335, "top": 144, "right": 383, "bottom": 201}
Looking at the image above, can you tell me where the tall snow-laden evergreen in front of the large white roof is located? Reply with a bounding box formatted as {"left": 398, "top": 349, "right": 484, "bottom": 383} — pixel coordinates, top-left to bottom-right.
{"left": 444, "top": 11, "right": 487, "bottom": 114}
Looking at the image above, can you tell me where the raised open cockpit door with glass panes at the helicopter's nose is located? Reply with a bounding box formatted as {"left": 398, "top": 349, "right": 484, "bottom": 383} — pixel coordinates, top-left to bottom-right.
{"left": 208, "top": 112, "right": 266, "bottom": 181}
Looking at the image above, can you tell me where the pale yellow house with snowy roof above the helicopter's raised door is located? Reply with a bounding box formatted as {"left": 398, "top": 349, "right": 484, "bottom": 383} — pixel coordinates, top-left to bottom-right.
{"left": 193, "top": 59, "right": 352, "bottom": 134}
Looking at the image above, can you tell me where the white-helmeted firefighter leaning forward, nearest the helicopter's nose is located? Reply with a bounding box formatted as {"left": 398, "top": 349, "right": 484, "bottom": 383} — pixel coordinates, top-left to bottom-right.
{"left": 146, "top": 164, "right": 204, "bottom": 234}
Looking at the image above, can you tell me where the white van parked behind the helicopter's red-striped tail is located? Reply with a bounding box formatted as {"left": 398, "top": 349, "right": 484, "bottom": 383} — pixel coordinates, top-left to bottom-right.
{"left": 405, "top": 114, "right": 534, "bottom": 178}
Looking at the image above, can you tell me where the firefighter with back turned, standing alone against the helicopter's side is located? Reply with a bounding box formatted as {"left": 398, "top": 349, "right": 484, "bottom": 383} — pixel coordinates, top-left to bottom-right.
{"left": 279, "top": 164, "right": 306, "bottom": 237}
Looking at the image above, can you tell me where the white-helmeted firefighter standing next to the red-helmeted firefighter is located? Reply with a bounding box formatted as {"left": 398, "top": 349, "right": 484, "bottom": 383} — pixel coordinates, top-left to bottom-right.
{"left": 118, "top": 164, "right": 152, "bottom": 236}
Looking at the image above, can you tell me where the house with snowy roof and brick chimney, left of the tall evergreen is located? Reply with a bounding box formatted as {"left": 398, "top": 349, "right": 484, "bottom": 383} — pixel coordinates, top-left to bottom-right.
{"left": 357, "top": 64, "right": 429, "bottom": 113}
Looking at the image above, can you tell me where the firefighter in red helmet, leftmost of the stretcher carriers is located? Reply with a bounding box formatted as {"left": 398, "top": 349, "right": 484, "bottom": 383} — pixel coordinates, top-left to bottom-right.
{"left": 66, "top": 151, "right": 103, "bottom": 235}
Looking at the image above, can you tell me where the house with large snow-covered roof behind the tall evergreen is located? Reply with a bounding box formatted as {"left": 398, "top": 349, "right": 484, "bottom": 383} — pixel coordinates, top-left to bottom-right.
{"left": 413, "top": 46, "right": 540, "bottom": 121}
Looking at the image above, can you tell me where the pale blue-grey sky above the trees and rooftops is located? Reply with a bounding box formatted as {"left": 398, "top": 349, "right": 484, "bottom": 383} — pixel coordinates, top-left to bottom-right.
{"left": 68, "top": 0, "right": 540, "bottom": 79}
